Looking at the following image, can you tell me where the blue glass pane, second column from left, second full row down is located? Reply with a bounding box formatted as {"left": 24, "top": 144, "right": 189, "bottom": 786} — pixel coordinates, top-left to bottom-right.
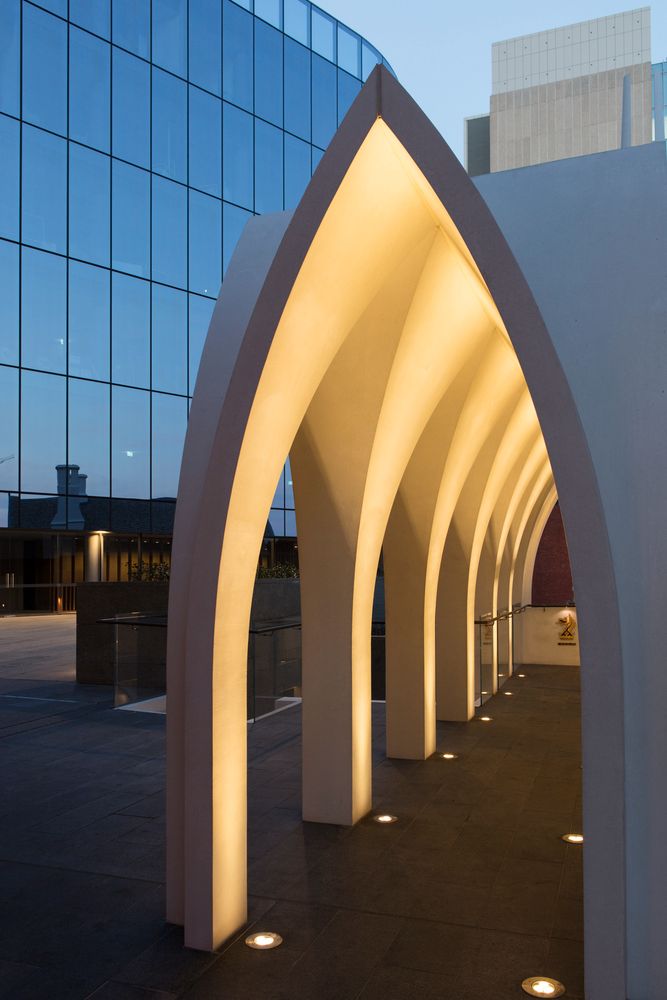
{"left": 22, "top": 125, "right": 67, "bottom": 253}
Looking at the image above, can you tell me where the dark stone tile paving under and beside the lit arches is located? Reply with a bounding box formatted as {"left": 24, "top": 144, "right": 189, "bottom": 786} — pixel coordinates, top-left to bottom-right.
{"left": 0, "top": 619, "right": 583, "bottom": 1000}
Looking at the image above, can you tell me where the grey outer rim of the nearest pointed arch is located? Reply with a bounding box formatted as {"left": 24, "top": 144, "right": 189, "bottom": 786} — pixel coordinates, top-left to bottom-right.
{"left": 167, "top": 66, "right": 626, "bottom": 1000}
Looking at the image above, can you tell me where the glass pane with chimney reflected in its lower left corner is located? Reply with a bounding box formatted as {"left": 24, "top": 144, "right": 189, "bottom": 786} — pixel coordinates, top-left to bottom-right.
{"left": 68, "top": 378, "right": 110, "bottom": 496}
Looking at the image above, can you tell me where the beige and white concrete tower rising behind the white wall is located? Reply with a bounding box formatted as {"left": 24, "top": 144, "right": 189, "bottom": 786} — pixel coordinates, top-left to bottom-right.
{"left": 465, "top": 7, "right": 654, "bottom": 176}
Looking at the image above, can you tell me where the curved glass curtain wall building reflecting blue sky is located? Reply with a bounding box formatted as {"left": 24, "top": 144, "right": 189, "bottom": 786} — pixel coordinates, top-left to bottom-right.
{"left": 0, "top": 0, "right": 392, "bottom": 613}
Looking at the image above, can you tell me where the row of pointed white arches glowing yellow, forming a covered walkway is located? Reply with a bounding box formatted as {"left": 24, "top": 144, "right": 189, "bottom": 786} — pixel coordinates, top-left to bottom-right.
{"left": 168, "top": 62, "right": 664, "bottom": 1000}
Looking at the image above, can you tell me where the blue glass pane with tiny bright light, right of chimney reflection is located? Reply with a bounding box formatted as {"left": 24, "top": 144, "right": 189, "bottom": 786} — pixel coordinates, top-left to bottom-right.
{"left": 111, "top": 385, "right": 150, "bottom": 498}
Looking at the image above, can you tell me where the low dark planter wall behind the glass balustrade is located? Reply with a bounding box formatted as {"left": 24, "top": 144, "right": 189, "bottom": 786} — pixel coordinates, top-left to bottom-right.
{"left": 76, "top": 579, "right": 301, "bottom": 684}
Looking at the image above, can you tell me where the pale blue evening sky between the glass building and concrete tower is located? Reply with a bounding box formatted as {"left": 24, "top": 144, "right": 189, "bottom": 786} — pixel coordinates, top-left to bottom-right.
{"left": 319, "top": 0, "right": 667, "bottom": 159}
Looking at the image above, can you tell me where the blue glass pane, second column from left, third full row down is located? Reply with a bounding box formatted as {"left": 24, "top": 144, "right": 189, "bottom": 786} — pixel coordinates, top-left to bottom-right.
{"left": 21, "top": 248, "right": 67, "bottom": 376}
